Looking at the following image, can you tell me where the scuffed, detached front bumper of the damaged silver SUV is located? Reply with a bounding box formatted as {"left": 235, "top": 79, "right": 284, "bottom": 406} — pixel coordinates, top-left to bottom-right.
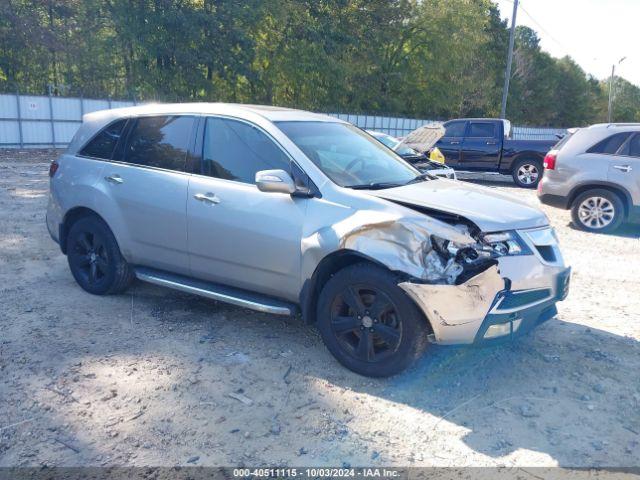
{"left": 399, "top": 255, "right": 571, "bottom": 345}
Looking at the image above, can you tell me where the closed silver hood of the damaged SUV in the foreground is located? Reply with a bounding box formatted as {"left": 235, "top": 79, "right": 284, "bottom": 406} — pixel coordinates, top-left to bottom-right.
{"left": 366, "top": 179, "right": 549, "bottom": 232}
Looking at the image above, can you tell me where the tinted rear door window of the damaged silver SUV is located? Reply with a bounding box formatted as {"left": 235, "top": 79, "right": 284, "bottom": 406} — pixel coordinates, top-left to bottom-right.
{"left": 124, "top": 116, "right": 193, "bottom": 170}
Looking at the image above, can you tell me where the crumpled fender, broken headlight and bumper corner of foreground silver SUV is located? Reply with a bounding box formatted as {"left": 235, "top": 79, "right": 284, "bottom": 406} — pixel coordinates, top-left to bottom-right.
{"left": 306, "top": 206, "right": 557, "bottom": 344}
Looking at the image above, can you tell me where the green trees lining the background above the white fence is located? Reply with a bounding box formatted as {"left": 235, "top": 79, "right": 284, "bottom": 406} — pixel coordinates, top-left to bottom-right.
{"left": 0, "top": 0, "right": 640, "bottom": 126}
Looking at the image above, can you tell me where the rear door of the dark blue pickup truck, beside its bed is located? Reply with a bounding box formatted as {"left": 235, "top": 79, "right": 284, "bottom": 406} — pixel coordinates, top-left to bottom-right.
{"left": 460, "top": 120, "right": 502, "bottom": 170}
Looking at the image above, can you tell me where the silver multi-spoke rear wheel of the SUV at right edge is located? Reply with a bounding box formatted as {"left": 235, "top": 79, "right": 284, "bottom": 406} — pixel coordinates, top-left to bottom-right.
{"left": 571, "top": 188, "right": 624, "bottom": 232}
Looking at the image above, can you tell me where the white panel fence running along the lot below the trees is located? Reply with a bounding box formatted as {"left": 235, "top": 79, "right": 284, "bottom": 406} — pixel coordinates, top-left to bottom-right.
{"left": 0, "top": 94, "right": 566, "bottom": 148}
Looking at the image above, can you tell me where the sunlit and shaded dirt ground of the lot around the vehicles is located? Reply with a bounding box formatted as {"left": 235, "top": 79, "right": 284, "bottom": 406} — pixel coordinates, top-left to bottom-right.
{"left": 0, "top": 148, "right": 640, "bottom": 467}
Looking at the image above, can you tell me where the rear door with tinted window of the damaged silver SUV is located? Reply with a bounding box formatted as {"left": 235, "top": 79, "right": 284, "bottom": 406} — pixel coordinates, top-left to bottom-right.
{"left": 101, "top": 116, "right": 195, "bottom": 274}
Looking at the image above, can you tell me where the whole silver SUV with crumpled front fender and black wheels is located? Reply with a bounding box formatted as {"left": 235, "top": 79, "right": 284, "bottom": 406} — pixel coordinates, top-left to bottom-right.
{"left": 47, "top": 104, "right": 569, "bottom": 376}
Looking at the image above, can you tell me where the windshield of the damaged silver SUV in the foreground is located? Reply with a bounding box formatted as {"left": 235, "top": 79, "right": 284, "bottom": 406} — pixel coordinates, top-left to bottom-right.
{"left": 276, "top": 122, "right": 420, "bottom": 188}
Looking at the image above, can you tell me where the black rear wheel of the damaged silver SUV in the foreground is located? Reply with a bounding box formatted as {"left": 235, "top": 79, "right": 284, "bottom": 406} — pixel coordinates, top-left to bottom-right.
{"left": 67, "top": 216, "right": 134, "bottom": 295}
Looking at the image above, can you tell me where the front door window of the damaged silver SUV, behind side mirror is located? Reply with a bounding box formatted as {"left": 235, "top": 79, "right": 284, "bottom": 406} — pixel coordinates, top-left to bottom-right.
{"left": 202, "top": 118, "right": 291, "bottom": 183}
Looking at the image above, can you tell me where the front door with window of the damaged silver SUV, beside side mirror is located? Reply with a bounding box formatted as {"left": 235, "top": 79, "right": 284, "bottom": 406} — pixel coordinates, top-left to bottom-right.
{"left": 187, "top": 117, "right": 309, "bottom": 300}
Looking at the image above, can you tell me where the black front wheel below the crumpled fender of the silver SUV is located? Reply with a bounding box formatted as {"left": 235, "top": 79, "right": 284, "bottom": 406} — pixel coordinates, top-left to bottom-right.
{"left": 317, "top": 263, "right": 428, "bottom": 377}
